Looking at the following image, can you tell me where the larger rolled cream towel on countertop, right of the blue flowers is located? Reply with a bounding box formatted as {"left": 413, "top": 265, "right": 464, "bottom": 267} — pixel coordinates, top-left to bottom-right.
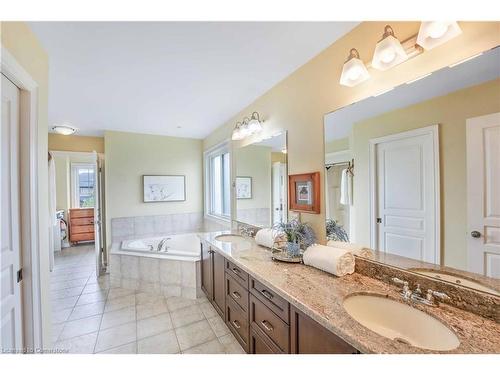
{"left": 303, "top": 245, "right": 354, "bottom": 276}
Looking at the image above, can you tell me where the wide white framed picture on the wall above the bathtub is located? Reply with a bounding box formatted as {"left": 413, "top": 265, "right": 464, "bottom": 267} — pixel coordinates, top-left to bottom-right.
{"left": 142, "top": 175, "right": 186, "bottom": 203}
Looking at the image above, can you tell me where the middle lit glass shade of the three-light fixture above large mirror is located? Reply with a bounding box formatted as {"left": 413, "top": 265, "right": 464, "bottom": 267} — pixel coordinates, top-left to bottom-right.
{"left": 372, "top": 25, "right": 408, "bottom": 70}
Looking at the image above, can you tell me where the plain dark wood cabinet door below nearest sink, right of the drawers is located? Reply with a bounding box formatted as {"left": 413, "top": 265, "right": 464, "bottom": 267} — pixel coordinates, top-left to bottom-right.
{"left": 290, "top": 306, "right": 359, "bottom": 354}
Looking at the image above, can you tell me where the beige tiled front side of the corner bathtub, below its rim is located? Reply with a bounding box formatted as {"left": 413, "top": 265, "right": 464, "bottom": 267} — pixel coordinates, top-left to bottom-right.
{"left": 109, "top": 247, "right": 202, "bottom": 299}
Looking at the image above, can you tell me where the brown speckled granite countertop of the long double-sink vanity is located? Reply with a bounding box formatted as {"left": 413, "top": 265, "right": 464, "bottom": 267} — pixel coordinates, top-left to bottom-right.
{"left": 199, "top": 231, "right": 500, "bottom": 354}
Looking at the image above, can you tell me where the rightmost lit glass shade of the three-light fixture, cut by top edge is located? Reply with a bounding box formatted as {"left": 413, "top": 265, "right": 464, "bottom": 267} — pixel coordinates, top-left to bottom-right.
{"left": 417, "top": 21, "right": 462, "bottom": 50}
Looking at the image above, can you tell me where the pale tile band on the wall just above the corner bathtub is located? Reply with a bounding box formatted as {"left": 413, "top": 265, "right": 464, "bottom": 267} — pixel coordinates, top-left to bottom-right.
{"left": 111, "top": 212, "right": 229, "bottom": 243}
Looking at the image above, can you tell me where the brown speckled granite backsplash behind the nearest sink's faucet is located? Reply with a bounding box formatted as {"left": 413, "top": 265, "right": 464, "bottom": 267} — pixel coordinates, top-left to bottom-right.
{"left": 356, "top": 257, "right": 500, "bottom": 323}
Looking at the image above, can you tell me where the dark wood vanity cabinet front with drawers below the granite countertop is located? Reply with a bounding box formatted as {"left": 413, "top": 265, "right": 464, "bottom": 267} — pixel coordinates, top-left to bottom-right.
{"left": 201, "top": 243, "right": 359, "bottom": 354}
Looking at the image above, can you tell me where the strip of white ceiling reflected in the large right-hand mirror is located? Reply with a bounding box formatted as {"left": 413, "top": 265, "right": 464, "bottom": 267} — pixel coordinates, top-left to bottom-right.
{"left": 324, "top": 48, "right": 500, "bottom": 142}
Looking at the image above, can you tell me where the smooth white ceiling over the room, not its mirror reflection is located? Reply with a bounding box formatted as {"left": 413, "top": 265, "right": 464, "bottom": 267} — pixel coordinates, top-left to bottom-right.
{"left": 30, "top": 22, "right": 357, "bottom": 138}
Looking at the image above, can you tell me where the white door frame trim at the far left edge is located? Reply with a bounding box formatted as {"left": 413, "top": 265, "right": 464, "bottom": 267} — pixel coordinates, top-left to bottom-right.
{"left": 0, "top": 44, "right": 43, "bottom": 349}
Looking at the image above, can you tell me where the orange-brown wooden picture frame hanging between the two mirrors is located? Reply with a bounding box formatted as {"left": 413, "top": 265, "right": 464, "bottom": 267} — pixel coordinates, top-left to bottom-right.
{"left": 288, "top": 172, "right": 320, "bottom": 214}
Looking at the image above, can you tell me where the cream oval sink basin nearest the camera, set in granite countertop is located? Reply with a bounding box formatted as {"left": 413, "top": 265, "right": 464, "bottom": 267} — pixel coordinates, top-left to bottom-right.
{"left": 344, "top": 295, "right": 460, "bottom": 351}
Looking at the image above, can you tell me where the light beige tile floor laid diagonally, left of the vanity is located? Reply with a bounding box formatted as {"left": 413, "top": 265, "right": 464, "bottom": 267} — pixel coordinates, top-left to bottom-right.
{"left": 51, "top": 245, "right": 244, "bottom": 354}
